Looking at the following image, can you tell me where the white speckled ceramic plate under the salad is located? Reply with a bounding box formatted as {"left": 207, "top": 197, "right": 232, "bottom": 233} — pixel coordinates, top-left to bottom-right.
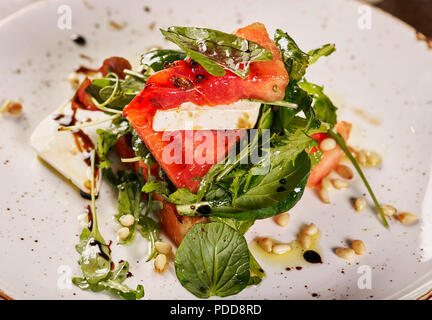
{"left": 0, "top": 0, "right": 432, "bottom": 299}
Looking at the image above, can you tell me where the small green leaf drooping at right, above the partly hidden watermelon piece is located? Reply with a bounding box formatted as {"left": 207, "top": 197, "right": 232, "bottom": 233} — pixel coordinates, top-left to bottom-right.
{"left": 298, "top": 80, "right": 337, "bottom": 128}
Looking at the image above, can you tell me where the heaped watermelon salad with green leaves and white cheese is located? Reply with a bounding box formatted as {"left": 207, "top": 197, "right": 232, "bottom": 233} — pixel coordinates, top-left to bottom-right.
{"left": 32, "top": 23, "right": 387, "bottom": 299}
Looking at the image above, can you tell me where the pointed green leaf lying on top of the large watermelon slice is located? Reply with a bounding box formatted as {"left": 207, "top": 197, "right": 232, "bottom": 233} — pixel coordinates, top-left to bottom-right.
{"left": 161, "top": 26, "right": 273, "bottom": 78}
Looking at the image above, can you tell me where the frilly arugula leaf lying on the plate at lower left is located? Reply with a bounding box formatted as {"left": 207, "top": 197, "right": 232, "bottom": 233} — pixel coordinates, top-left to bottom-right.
{"left": 72, "top": 261, "right": 144, "bottom": 300}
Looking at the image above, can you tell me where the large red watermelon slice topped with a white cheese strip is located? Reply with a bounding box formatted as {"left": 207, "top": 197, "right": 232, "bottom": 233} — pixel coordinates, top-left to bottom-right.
{"left": 124, "top": 23, "right": 289, "bottom": 192}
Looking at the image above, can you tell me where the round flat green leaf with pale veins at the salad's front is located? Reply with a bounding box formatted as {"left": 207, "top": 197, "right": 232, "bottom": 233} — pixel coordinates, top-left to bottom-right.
{"left": 175, "top": 222, "right": 250, "bottom": 298}
